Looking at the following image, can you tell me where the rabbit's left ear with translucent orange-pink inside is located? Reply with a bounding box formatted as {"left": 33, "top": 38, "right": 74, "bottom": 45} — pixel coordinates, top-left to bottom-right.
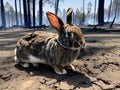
{"left": 46, "top": 12, "right": 64, "bottom": 30}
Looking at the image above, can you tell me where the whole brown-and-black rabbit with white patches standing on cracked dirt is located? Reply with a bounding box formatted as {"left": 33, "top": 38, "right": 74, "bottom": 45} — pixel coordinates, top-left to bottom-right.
{"left": 14, "top": 8, "right": 85, "bottom": 75}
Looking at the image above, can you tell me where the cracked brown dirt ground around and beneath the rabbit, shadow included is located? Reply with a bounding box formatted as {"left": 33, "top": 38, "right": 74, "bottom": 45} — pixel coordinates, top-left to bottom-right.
{"left": 0, "top": 29, "right": 120, "bottom": 90}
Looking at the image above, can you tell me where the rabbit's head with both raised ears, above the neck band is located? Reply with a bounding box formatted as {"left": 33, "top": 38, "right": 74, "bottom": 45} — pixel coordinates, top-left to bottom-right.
{"left": 46, "top": 8, "right": 85, "bottom": 49}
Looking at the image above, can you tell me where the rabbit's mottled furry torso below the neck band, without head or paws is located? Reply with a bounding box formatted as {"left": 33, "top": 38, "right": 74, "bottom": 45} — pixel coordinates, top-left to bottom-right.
{"left": 16, "top": 32, "right": 79, "bottom": 66}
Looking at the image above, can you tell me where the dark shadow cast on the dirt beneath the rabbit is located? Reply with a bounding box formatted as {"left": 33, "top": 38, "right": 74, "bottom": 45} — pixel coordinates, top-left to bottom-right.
{"left": 15, "top": 64, "right": 91, "bottom": 88}
